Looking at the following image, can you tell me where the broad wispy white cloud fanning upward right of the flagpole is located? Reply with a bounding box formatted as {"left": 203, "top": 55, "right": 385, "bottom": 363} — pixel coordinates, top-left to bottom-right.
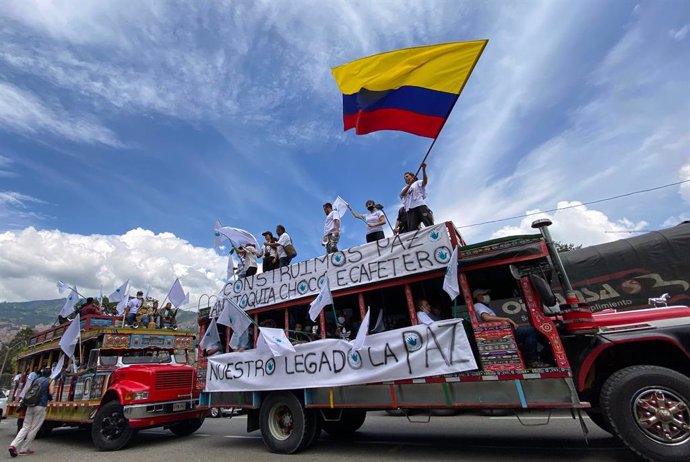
{"left": 429, "top": 2, "right": 690, "bottom": 240}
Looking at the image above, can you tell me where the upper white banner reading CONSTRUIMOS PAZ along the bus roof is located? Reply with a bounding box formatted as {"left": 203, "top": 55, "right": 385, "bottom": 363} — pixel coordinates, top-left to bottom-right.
{"left": 222, "top": 224, "right": 452, "bottom": 309}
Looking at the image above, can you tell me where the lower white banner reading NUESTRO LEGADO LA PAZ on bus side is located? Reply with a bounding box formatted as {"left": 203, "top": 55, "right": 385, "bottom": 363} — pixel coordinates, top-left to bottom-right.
{"left": 206, "top": 319, "right": 477, "bottom": 391}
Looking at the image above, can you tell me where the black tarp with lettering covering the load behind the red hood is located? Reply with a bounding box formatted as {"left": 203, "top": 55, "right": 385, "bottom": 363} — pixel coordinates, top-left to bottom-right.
{"left": 554, "top": 222, "right": 690, "bottom": 311}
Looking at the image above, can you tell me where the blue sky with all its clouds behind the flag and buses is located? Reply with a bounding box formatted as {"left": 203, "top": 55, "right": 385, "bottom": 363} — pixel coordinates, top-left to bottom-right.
{"left": 0, "top": 0, "right": 690, "bottom": 300}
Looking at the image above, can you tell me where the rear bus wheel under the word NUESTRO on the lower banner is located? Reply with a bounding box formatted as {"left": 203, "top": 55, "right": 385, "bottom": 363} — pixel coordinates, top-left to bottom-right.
{"left": 259, "top": 391, "right": 312, "bottom": 454}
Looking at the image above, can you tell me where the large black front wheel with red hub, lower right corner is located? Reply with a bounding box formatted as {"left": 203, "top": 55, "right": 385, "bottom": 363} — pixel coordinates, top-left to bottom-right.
{"left": 601, "top": 366, "right": 690, "bottom": 462}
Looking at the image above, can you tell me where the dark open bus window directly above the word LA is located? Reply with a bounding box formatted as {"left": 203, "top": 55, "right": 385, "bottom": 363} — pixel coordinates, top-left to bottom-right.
{"left": 364, "top": 286, "right": 412, "bottom": 332}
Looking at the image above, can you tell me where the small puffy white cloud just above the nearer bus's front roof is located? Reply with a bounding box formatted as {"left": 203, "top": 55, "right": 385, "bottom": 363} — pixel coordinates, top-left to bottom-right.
{"left": 492, "top": 201, "right": 647, "bottom": 247}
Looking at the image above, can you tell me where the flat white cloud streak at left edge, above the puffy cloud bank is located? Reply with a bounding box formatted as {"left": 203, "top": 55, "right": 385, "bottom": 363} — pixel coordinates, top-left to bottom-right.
{"left": 0, "top": 81, "right": 119, "bottom": 146}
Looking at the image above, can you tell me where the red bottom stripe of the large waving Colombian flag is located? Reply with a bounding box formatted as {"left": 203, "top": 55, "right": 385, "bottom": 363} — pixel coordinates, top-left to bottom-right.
{"left": 343, "top": 109, "right": 446, "bottom": 138}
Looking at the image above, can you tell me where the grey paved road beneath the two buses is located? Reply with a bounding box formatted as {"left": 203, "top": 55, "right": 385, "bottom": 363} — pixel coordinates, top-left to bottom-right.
{"left": 0, "top": 412, "right": 636, "bottom": 462}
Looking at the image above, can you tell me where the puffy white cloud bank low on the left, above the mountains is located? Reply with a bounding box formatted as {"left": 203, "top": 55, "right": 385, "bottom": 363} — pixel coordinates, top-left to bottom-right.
{"left": 0, "top": 227, "right": 227, "bottom": 309}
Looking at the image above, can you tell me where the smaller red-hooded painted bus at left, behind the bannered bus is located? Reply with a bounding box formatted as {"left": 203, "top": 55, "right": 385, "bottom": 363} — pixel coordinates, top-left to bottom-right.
{"left": 7, "top": 315, "right": 207, "bottom": 451}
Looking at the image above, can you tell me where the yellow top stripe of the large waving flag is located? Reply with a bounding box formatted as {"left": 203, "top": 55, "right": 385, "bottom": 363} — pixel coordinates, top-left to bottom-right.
{"left": 332, "top": 40, "right": 488, "bottom": 95}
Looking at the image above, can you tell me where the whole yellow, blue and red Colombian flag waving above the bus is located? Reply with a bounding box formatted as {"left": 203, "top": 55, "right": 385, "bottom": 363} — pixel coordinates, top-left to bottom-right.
{"left": 332, "top": 40, "right": 488, "bottom": 138}
